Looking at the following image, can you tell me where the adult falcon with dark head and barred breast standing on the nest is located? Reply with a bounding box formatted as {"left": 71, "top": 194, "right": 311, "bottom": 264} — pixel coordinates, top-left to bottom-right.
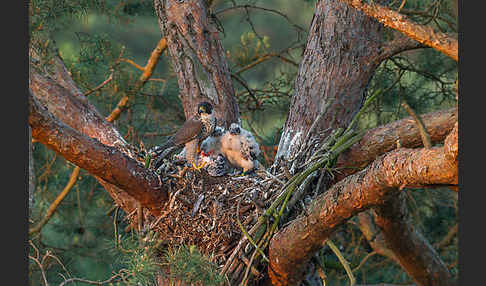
{"left": 154, "top": 101, "right": 216, "bottom": 169}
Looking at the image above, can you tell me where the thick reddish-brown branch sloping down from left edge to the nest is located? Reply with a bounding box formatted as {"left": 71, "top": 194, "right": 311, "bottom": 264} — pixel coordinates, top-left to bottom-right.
{"left": 29, "top": 92, "right": 168, "bottom": 215}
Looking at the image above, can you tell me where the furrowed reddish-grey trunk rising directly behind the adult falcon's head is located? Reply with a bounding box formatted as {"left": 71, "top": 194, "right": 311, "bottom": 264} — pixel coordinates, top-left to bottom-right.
{"left": 154, "top": 0, "right": 240, "bottom": 127}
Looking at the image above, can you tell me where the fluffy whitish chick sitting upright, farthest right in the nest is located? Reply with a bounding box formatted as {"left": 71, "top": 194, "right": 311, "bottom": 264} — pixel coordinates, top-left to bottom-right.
{"left": 220, "top": 123, "right": 260, "bottom": 174}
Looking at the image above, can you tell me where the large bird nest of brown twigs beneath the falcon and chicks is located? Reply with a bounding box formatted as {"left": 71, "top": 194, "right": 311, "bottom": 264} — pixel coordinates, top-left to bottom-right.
{"left": 140, "top": 158, "right": 282, "bottom": 281}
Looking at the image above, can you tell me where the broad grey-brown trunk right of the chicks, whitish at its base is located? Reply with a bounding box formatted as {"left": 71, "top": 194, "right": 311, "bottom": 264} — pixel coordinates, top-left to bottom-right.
{"left": 276, "top": 0, "right": 384, "bottom": 159}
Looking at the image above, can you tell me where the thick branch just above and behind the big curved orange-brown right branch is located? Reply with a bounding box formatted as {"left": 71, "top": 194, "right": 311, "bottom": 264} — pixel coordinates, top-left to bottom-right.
{"left": 337, "top": 108, "right": 457, "bottom": 180}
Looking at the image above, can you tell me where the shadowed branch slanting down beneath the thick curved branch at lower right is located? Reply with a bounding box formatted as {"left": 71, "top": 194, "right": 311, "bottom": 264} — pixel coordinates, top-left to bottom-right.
{"left": 375, "top": 193, "right": 455, "bottom": 286}
